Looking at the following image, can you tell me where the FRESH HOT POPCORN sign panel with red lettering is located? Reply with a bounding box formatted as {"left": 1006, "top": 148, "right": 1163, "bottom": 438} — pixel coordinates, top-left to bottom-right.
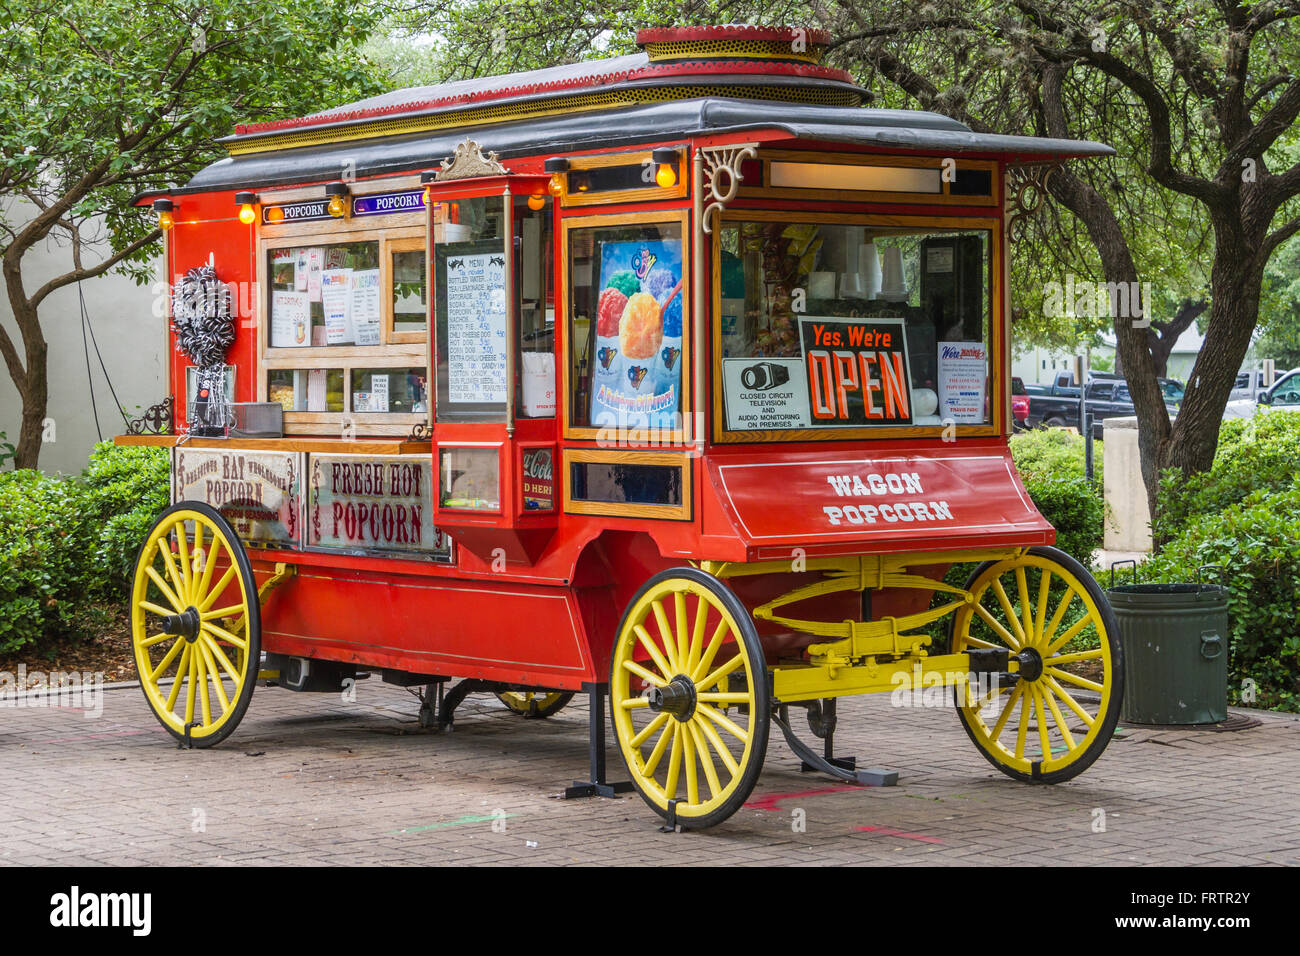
{"left": 307, "top": 455, "right": 451, "bottom": 562}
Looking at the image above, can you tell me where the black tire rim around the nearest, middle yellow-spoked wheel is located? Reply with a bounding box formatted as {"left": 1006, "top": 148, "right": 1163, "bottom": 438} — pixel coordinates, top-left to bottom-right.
{"left": 610, "top": 567, "right": 772, "bottom": 830}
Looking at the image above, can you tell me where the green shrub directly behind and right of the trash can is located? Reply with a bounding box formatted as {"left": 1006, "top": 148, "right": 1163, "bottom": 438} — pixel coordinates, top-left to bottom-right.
{"left": 1143, "top": 486, "right": 1300, "bottom": 711}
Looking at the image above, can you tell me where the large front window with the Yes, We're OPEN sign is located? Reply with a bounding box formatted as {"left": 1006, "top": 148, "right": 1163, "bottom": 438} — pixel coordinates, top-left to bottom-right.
{"left": 714, "top": 212, "right": 997, "bottom": 441}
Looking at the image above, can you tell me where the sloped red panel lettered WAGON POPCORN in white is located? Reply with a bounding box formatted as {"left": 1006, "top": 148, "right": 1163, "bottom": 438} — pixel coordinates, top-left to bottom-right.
{"left": 709, "top": 442, "right": 1054, "bottom": 553}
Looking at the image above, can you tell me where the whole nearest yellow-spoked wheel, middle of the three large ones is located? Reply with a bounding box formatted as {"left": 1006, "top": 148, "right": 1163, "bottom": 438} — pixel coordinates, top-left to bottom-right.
{"left": 610, "top": 567, "right": 771, "bottom": 829}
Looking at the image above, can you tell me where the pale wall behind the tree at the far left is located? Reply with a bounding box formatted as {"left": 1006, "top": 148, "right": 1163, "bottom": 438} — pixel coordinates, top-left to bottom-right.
{"left": 0, "top": 207, "right": 166, "bottom": 473}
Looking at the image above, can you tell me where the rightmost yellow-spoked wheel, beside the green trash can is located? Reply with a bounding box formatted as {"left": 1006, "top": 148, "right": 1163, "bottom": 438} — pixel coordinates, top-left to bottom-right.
{"left": 952, "top": 548, "right": 1123, "bottom": 783}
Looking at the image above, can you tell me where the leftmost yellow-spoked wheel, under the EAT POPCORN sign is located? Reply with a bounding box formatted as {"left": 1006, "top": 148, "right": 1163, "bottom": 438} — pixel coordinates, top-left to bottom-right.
{"left": 131, "top": 502, "right": 261, "bottom": 747}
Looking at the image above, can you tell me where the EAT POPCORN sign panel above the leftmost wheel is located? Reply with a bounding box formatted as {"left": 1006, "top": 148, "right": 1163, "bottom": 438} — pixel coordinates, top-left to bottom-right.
{"left": 172, "top": 447, "right": 303, "bottom": 548}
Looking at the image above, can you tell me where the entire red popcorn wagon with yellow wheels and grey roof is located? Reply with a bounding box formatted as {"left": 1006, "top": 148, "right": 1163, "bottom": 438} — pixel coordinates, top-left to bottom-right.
{"left": 118, "top": 26, "right": 1123, "bottom": 827}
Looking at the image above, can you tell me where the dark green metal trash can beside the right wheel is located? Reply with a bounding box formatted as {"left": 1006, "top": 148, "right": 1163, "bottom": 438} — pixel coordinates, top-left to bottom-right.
{"left": 1106, "top": 567, "right": 1229, "bottom": 724}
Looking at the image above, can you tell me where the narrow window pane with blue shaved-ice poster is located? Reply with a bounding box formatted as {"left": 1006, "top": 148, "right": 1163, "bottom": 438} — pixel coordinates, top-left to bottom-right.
{"left": 568, "top": 222, "right": 689, "bottom": 429}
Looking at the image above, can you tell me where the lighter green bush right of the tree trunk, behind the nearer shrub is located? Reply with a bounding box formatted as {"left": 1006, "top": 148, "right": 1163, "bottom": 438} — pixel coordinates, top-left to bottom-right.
{"left": 1153, "top": 408, "right": 1300, "bottom": 541}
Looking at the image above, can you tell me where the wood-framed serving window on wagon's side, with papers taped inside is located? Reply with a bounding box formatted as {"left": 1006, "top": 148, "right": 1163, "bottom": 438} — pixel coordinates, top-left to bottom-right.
{"left": 257, "top": 215, "right": 430, "bottom": 434}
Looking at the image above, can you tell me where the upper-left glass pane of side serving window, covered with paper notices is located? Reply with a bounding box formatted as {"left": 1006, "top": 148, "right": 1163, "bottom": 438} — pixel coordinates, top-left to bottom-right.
{"left": 267, "top": 239, "right": 382, "bottom": 349}
